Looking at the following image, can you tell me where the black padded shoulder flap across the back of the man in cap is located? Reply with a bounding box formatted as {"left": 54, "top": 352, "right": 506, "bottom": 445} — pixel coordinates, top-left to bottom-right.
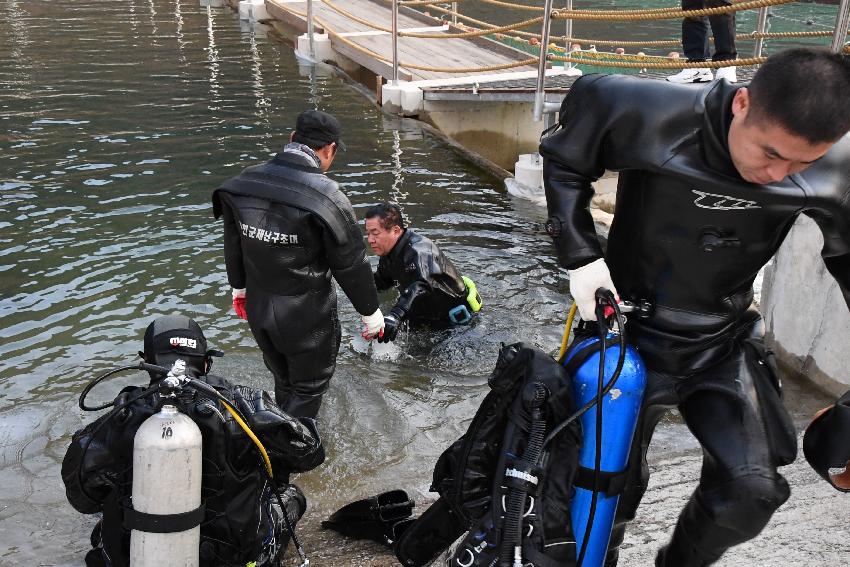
{"left": 213, "top": 172, "right": 349, "bottom": 245}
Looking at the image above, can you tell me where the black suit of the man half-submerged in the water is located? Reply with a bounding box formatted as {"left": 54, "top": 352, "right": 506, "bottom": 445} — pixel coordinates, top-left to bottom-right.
{"left": 375, "top": 228, "right": 472, "bottom": 323}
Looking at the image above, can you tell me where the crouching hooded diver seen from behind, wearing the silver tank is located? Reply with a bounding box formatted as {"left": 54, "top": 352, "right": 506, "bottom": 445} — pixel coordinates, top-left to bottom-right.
{"left": 62, "top": 315, "right": 325, "bottom": 567}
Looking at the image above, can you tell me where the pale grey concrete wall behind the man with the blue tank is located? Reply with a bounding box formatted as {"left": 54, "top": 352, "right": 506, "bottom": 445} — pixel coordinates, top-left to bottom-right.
{"left": 762, "top": 216, "right": 850, "bottom": 394}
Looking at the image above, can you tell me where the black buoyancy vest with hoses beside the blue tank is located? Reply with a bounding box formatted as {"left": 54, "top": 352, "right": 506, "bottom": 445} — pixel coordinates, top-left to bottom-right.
{"left": 396, "top": 343, "right": 581, "bottom": 567}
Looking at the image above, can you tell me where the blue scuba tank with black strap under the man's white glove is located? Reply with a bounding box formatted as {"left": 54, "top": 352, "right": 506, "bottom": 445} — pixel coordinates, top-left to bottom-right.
{"left": 564, "top": 333, "right": 646, "bottom": 567}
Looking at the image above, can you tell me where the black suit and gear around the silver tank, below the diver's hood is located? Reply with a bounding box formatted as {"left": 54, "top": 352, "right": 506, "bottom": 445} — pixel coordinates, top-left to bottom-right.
{"left": 62, "top": 376, "right": 325, "bottom": 567}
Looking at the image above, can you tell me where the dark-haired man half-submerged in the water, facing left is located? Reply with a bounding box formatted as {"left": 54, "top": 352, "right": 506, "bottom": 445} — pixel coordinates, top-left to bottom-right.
{"left": 366, "top": 203, "right": 481, "bottom": 342}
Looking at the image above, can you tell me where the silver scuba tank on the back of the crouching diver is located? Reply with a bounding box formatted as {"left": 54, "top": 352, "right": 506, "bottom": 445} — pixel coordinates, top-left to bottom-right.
{"left": 129, "top": 360, "right": 203, "bottom": 567}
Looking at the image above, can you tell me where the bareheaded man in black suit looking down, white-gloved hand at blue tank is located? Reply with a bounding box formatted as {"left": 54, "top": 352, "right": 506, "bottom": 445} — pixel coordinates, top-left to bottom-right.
{"left": 540, "top": 48, "right": 850, "bottom": 567}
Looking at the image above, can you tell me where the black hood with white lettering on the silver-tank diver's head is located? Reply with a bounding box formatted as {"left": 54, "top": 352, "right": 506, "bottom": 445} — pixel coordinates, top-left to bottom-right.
{"left": 142, "top": 314, "right": 208, "bottom": 378}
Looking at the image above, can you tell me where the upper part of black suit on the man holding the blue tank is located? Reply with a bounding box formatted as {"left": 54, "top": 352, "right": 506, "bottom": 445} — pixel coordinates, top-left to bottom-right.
{"left": 540, "top": 75, "right": 850, "bottom": 374}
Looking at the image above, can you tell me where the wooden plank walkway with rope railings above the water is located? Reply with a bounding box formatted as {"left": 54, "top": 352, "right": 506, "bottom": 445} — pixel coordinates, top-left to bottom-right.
{"left": 266, "top": 0, "right": 537, "bottom": 82}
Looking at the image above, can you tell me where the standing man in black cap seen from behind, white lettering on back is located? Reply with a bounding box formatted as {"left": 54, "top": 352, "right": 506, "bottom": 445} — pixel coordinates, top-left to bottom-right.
{"left": 213, "top": 110, "right": 384, "bottom": 417}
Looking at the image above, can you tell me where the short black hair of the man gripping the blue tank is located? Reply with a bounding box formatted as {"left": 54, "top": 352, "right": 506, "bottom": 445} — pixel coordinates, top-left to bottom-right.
{"left": 747, "top": 47, "right": 850, "bottom": 144}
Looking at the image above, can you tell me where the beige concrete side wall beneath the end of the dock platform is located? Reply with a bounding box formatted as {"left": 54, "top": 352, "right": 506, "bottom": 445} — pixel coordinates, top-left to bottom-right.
{"left": 419, "top": 100, "right": 543, "bottom": 171}
